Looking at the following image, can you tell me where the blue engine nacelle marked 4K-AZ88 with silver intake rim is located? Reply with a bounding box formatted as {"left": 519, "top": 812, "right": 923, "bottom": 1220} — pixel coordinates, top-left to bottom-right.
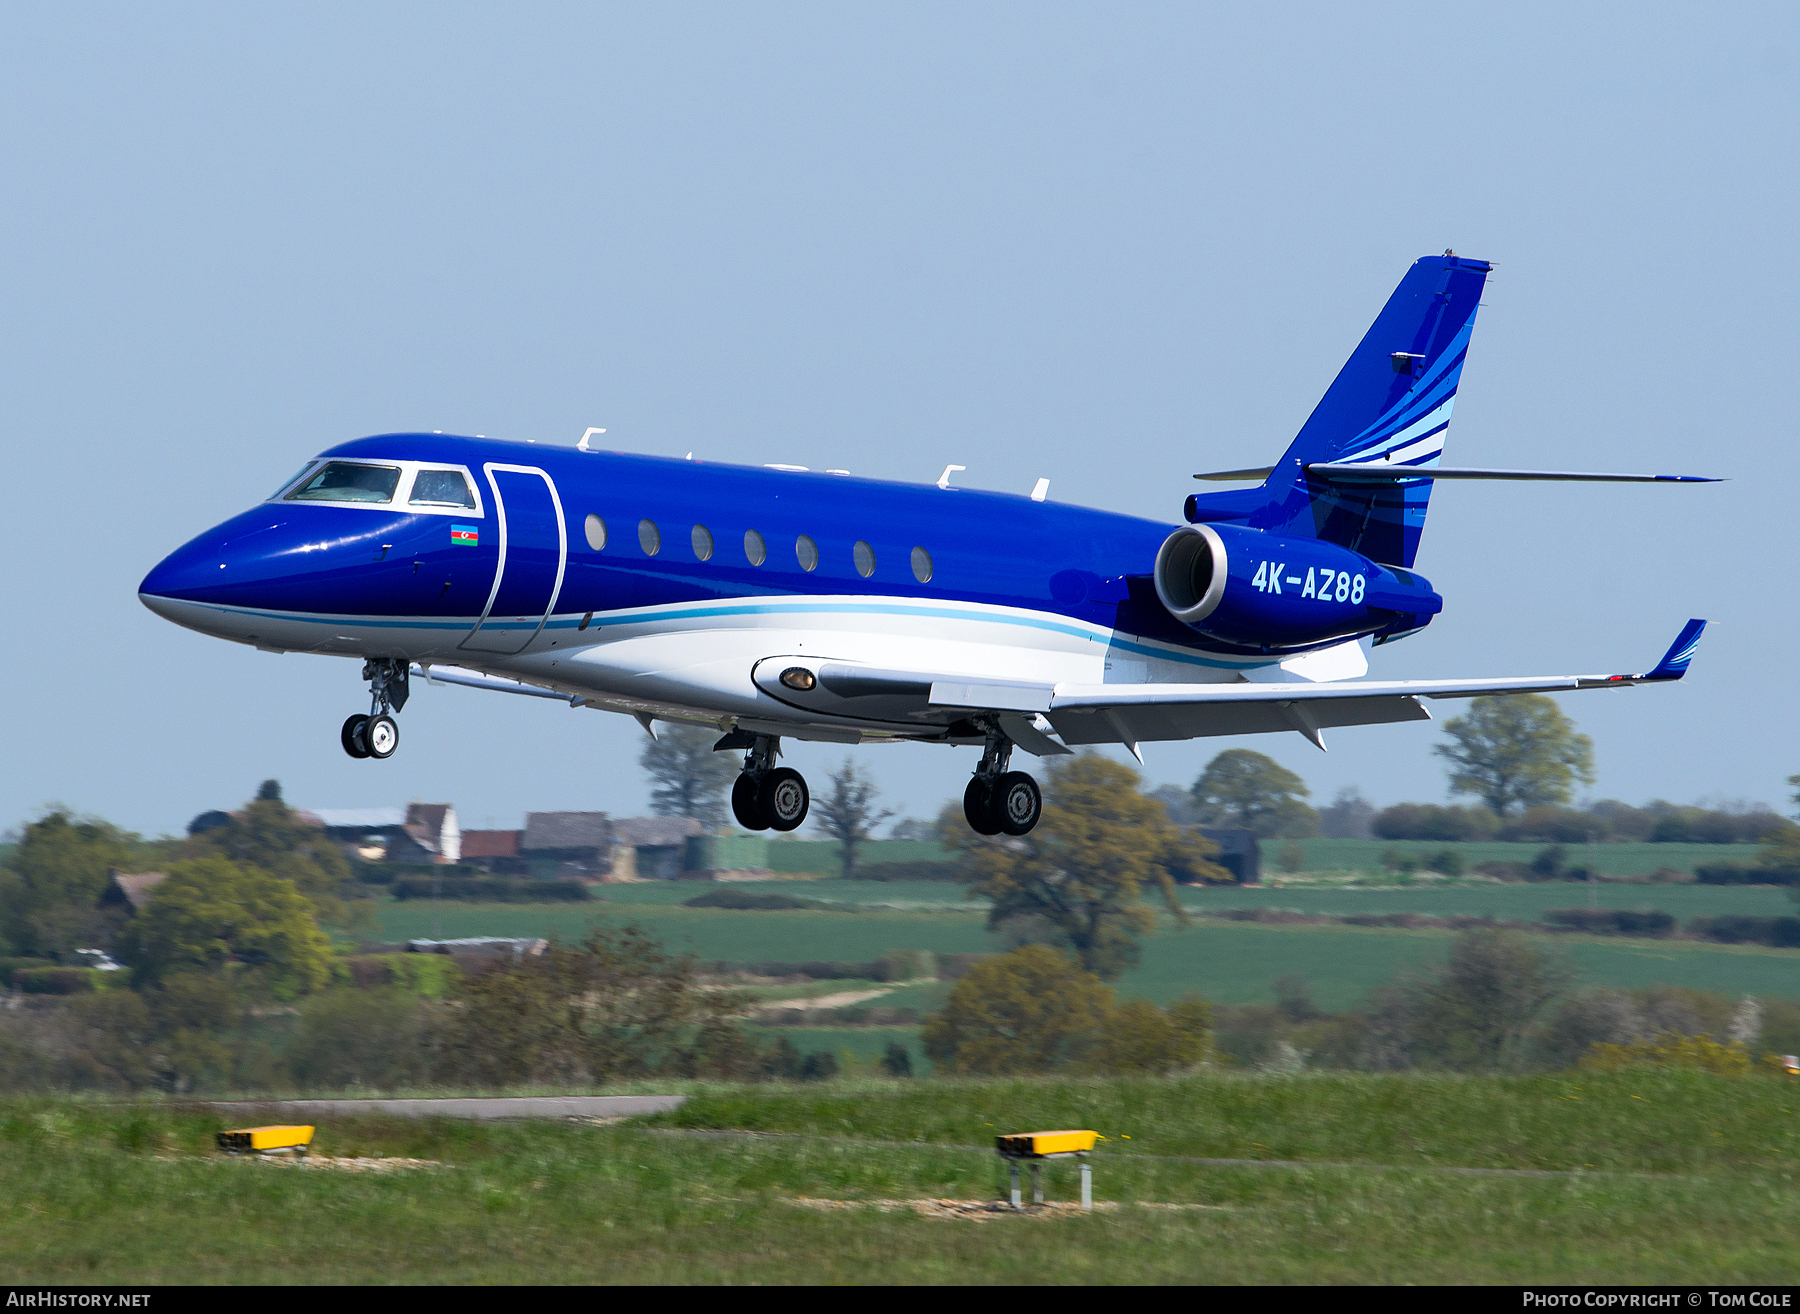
{"left": 1154, "top": 524, "right": 1444, "bottom": 652}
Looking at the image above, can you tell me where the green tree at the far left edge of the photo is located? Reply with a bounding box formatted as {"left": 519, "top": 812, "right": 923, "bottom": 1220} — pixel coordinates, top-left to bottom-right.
{"left": 0, "top": 806, "right": 135, "bottom": 958}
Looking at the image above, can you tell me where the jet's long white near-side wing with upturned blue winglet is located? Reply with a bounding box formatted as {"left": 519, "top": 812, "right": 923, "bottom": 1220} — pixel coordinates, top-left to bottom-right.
{"left": 931, "top": 621, "right": 1706, "bottom": 754}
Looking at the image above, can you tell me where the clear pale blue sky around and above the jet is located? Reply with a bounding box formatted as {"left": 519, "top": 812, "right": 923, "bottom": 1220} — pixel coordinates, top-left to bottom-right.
{"left": 0, "top": 4, "right": 1800, "bottom": 833}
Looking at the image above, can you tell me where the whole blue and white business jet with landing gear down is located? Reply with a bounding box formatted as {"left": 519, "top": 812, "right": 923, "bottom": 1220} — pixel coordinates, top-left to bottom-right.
{"left": 139, "top": 252, "right": 1712, "bottom": 835}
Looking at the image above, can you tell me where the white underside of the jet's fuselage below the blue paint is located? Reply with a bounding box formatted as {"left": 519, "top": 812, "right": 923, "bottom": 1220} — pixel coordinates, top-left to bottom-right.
{"left": 142, "top": 596, "right": 1303, "bottom": 742}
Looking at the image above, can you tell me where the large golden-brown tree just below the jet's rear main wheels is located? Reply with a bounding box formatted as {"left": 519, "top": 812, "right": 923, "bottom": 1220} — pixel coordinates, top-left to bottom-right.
{"left": 959, "top": 752, "right": 1229, "bottom": 979}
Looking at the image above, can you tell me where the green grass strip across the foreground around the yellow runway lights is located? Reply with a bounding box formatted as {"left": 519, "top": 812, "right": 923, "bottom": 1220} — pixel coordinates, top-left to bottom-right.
{"left": 10, "top": 1073, "right": 1800, "bottom": 1285}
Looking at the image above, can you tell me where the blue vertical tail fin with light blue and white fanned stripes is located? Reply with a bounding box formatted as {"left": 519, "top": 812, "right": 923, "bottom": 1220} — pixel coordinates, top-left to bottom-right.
{"left": 1251, "top": 252, "right": 1492, "bottom": 567}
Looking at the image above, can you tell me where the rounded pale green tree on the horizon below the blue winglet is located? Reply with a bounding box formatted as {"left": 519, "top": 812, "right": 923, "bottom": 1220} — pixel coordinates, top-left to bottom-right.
{"left": 1431, "top": 693, "right": 1593, "bottom": 817}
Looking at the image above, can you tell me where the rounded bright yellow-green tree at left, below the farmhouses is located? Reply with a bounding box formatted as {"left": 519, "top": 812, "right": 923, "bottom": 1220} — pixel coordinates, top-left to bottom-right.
{"left": 121, "top": 857, "right": 331, "bottom": 995}
